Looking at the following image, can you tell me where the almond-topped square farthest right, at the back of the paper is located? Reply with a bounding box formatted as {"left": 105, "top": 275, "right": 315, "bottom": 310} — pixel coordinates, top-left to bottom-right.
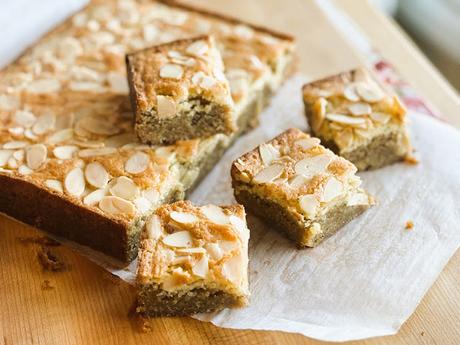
{"left": 303, "top": 68, "right": 411, "bottom": 170}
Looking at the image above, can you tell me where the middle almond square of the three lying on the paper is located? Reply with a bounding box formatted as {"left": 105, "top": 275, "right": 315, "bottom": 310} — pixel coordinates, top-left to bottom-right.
{"left": 231, "top": 129, "right": 374, "bottom": 247}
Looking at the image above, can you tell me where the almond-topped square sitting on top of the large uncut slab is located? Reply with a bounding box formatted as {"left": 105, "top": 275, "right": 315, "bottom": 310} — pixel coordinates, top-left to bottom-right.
{"left": 126, "top": 36, "right": 236, "bottom": 144}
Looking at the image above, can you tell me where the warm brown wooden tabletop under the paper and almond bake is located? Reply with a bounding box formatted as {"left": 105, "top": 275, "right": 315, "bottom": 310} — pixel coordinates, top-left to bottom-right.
{"left": 0, "top": 0, "right": 460, "bottom": 345}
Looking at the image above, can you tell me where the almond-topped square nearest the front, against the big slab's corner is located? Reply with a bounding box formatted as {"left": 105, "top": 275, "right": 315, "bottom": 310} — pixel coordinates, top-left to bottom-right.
{"left": 137, "top": 201, "right": 249, "bottom": 316}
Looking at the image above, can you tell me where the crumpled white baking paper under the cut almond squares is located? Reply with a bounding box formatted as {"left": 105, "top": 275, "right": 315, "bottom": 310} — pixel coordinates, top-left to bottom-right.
{"left": 75, "top": 76, "right": 460, "bottom": 341}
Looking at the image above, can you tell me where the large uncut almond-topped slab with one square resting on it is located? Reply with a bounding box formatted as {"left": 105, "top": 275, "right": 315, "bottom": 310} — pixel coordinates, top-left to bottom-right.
{"left": 0, "top": 0, "right": 293, "bottom": 261}
